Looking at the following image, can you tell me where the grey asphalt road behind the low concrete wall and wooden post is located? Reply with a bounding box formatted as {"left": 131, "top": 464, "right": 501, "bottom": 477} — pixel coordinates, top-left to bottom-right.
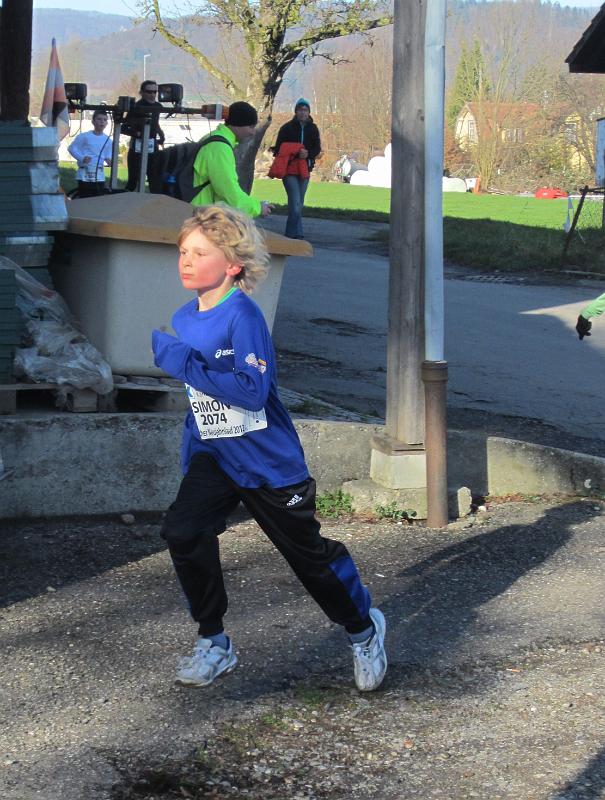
{"left": 270, "top": 220, "right": 605, "bottom": 440}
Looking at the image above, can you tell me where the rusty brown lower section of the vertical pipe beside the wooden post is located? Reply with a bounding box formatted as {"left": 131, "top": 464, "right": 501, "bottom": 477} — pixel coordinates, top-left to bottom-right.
{"left": 422, "top": 361, "right": 448, "bottom": 528}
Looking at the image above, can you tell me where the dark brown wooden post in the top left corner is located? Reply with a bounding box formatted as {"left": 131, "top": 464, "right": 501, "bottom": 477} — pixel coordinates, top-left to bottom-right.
{"left": 0, "top": 0, "right": 33, "bottom": 122}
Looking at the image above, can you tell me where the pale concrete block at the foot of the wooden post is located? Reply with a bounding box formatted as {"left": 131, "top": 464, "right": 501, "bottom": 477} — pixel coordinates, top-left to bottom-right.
{"left": 370, "top": 435, "right": 426, "bottom": 490}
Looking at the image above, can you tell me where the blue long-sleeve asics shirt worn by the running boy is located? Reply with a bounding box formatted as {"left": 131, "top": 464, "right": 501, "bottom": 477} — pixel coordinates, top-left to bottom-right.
{"left": 152, "top": 290, "right": 309, "bottom": 488}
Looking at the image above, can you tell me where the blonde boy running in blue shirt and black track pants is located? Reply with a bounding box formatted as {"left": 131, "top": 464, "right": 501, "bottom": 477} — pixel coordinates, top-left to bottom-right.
{"left": 153, "top": 206, "right": 387, "bottom": 691}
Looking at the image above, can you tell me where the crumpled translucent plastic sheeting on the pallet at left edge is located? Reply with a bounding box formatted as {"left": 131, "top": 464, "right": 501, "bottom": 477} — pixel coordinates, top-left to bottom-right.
{"left": 0, "top": 256, "right": 113, "bottom": 394}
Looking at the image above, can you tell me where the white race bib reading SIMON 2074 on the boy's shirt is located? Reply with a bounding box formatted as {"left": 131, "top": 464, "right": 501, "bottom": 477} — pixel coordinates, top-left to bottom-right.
{"left": 185, "top": 383, "right": 267, "bottom": 441}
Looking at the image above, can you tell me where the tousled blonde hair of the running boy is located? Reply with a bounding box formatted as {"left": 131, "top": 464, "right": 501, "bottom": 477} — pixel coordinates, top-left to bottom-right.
{"left": 177, "top": 206, "right": 269, "bottom": 294}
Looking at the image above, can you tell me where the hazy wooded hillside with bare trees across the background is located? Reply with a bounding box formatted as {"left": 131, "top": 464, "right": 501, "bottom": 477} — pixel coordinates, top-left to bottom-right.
{"left": 32, "top": 0, "right": 605, "bottom": 189}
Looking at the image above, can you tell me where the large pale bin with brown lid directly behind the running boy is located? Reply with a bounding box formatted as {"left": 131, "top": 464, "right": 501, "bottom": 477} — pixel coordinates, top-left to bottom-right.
{"left": 51, "top": 192, "right": 313, "bottom": 376}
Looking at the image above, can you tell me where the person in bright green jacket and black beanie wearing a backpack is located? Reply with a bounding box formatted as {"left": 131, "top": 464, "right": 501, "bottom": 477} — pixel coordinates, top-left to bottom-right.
{"left": 191, "top": 100, "right": 272, "bottom": 217}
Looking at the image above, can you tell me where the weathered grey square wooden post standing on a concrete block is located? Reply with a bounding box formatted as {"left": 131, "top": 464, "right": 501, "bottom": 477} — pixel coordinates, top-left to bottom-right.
{"left": 386, "top": 0, "right": 426, "bottom": 445}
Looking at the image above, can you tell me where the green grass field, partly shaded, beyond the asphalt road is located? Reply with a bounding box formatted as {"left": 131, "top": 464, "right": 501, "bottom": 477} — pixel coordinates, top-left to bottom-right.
{"left": 61, "top": 167, "right": 605, "bottom": 275}
